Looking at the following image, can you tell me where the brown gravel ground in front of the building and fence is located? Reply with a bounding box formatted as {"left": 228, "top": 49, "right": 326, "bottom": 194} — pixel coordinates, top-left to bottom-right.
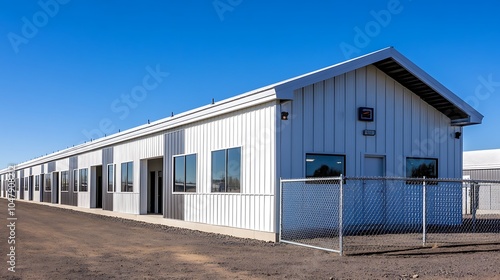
{"left": 0, "top": 199, "right": 500, "bottom": 279}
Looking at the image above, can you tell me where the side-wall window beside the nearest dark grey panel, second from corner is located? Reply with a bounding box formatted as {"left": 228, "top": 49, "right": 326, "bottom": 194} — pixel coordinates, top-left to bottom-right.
{"left": 174, "top": 155, "right": 196, "bottom": 192}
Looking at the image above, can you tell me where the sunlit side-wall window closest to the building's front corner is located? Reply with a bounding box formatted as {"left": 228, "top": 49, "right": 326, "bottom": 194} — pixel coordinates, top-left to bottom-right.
{"left": 212, "top": 148, "right": 241, "bottom": 192}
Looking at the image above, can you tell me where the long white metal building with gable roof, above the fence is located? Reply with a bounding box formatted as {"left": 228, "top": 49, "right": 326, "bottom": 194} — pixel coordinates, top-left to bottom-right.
{"left": 0, "top": 48, "right": 483, "bottom": 240}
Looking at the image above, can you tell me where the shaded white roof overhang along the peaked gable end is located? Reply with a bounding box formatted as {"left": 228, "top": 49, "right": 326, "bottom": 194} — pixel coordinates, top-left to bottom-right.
{"left": 276, "top": 47, "right": 483, "bottom": 126}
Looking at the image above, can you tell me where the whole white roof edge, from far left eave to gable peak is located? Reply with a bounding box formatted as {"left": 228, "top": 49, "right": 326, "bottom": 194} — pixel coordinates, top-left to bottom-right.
{"left": 0, "top": 47, "right": 483, "bottom": 173}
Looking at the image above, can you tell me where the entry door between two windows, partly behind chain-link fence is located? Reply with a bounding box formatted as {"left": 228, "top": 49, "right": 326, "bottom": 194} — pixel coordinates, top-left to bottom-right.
{"left": 363, "top": 156, "right": 386, "bottom": 225}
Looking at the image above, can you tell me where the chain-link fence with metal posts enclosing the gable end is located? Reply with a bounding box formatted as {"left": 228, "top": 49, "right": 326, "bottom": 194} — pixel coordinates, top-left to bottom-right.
{"left": 280, "top": 177, "right": 500, "bottom": 254}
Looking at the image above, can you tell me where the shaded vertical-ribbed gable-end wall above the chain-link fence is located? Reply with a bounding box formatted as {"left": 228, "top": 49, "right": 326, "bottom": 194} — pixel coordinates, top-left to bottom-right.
{"left": 280, "top": 65, "right": 462, "bottom": 178}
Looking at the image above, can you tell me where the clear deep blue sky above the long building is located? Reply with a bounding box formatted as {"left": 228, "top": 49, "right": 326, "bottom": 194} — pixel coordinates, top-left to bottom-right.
{"left": 0, "top": 0, "right": 500, "bottom": 168}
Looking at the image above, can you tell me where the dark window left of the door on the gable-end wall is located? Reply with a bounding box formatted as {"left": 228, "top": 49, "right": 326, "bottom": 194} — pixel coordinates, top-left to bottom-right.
{"left": 306, "top": 154, "right": 345, "bottom": 178}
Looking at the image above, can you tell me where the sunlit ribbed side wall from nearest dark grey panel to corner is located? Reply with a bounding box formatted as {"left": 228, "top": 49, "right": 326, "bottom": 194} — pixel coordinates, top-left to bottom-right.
{"left": 164, "top": 102, "right": 276, "bottom": 232}
